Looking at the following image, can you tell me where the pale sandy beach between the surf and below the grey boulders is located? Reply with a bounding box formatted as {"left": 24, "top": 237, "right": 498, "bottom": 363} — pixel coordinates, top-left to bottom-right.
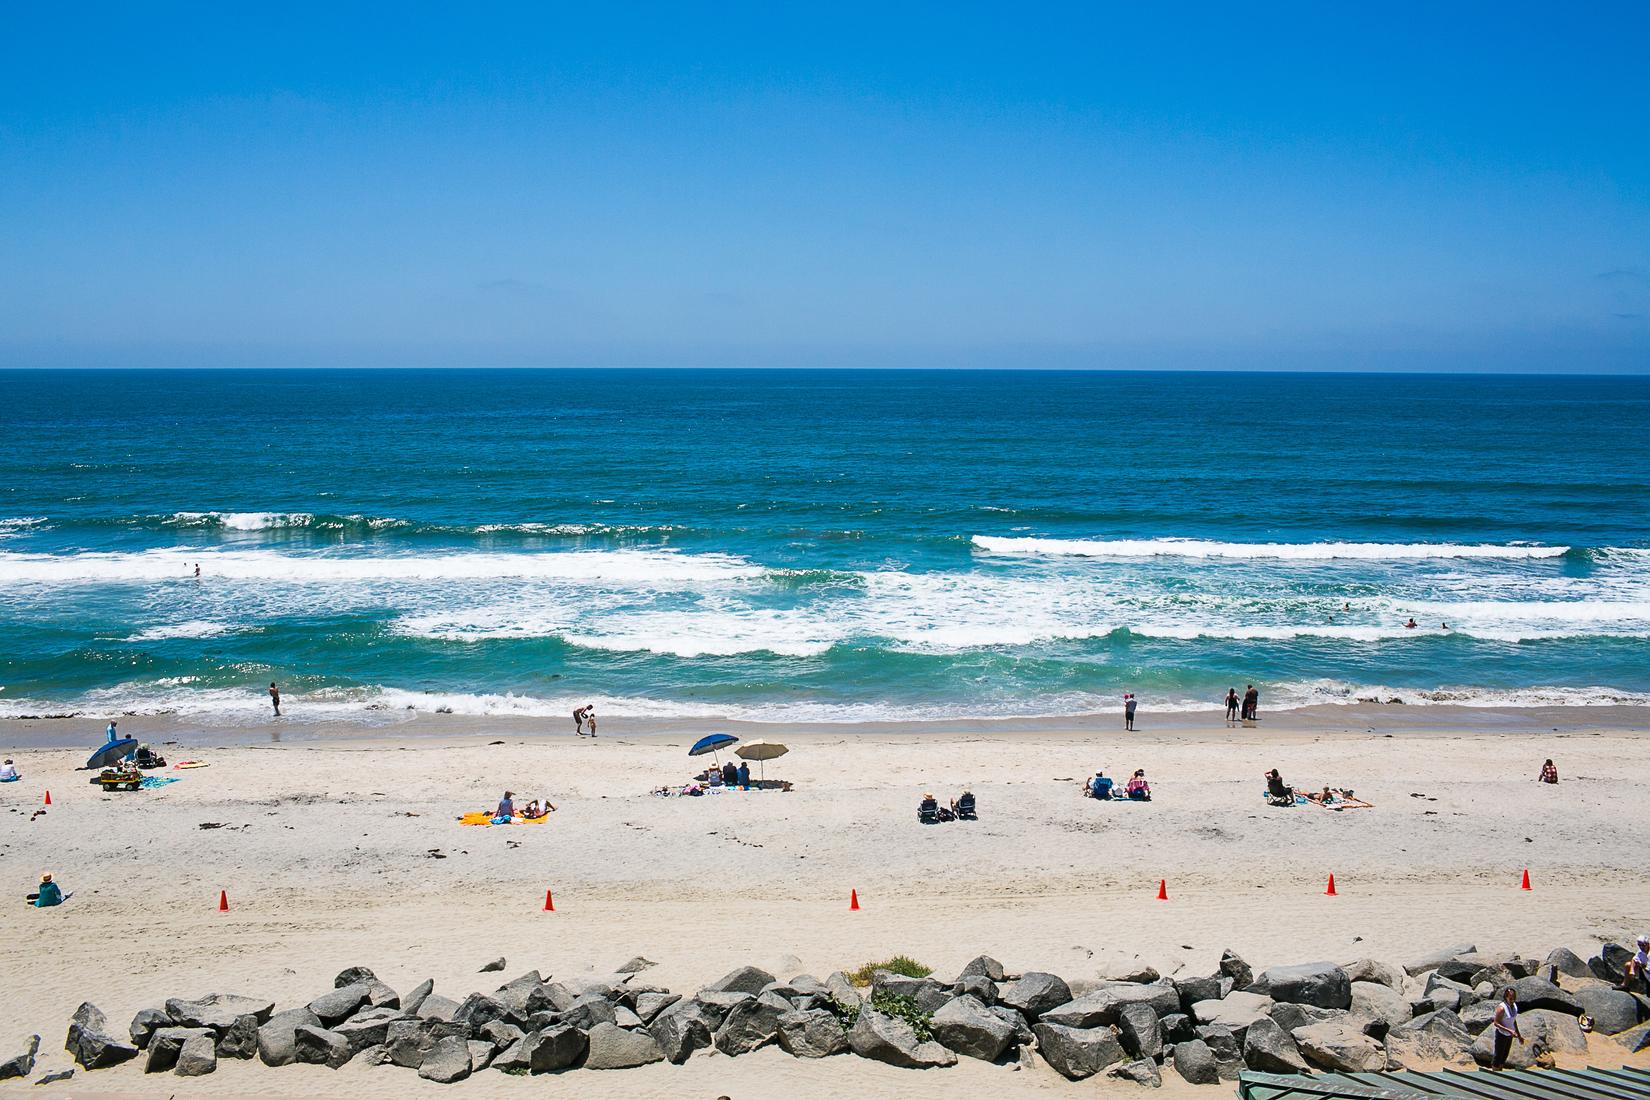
{"left": 0, "top": 707, "right": 1650, "bottom": 1097}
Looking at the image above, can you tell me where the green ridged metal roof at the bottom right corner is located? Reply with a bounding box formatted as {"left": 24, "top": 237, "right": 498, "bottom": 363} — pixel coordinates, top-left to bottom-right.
{"left": 1238, "top": 1065, "right": 1650, "bottom": 1100}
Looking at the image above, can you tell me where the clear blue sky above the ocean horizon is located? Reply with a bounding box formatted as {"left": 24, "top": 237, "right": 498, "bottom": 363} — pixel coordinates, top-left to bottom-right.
{"left": 0, "top": 2, "right": 1650, "bottom": 371}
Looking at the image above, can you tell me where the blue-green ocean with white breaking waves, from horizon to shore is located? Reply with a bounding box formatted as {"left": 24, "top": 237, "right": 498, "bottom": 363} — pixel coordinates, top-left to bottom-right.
{"left": 0, "top": 369, "right": 1650, "bottom": 722}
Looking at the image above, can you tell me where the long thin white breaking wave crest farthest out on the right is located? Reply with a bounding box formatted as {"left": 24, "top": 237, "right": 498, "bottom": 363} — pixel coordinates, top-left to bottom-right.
{"left": 974, "top": 534, "right": 1569, "bottom": 561}
